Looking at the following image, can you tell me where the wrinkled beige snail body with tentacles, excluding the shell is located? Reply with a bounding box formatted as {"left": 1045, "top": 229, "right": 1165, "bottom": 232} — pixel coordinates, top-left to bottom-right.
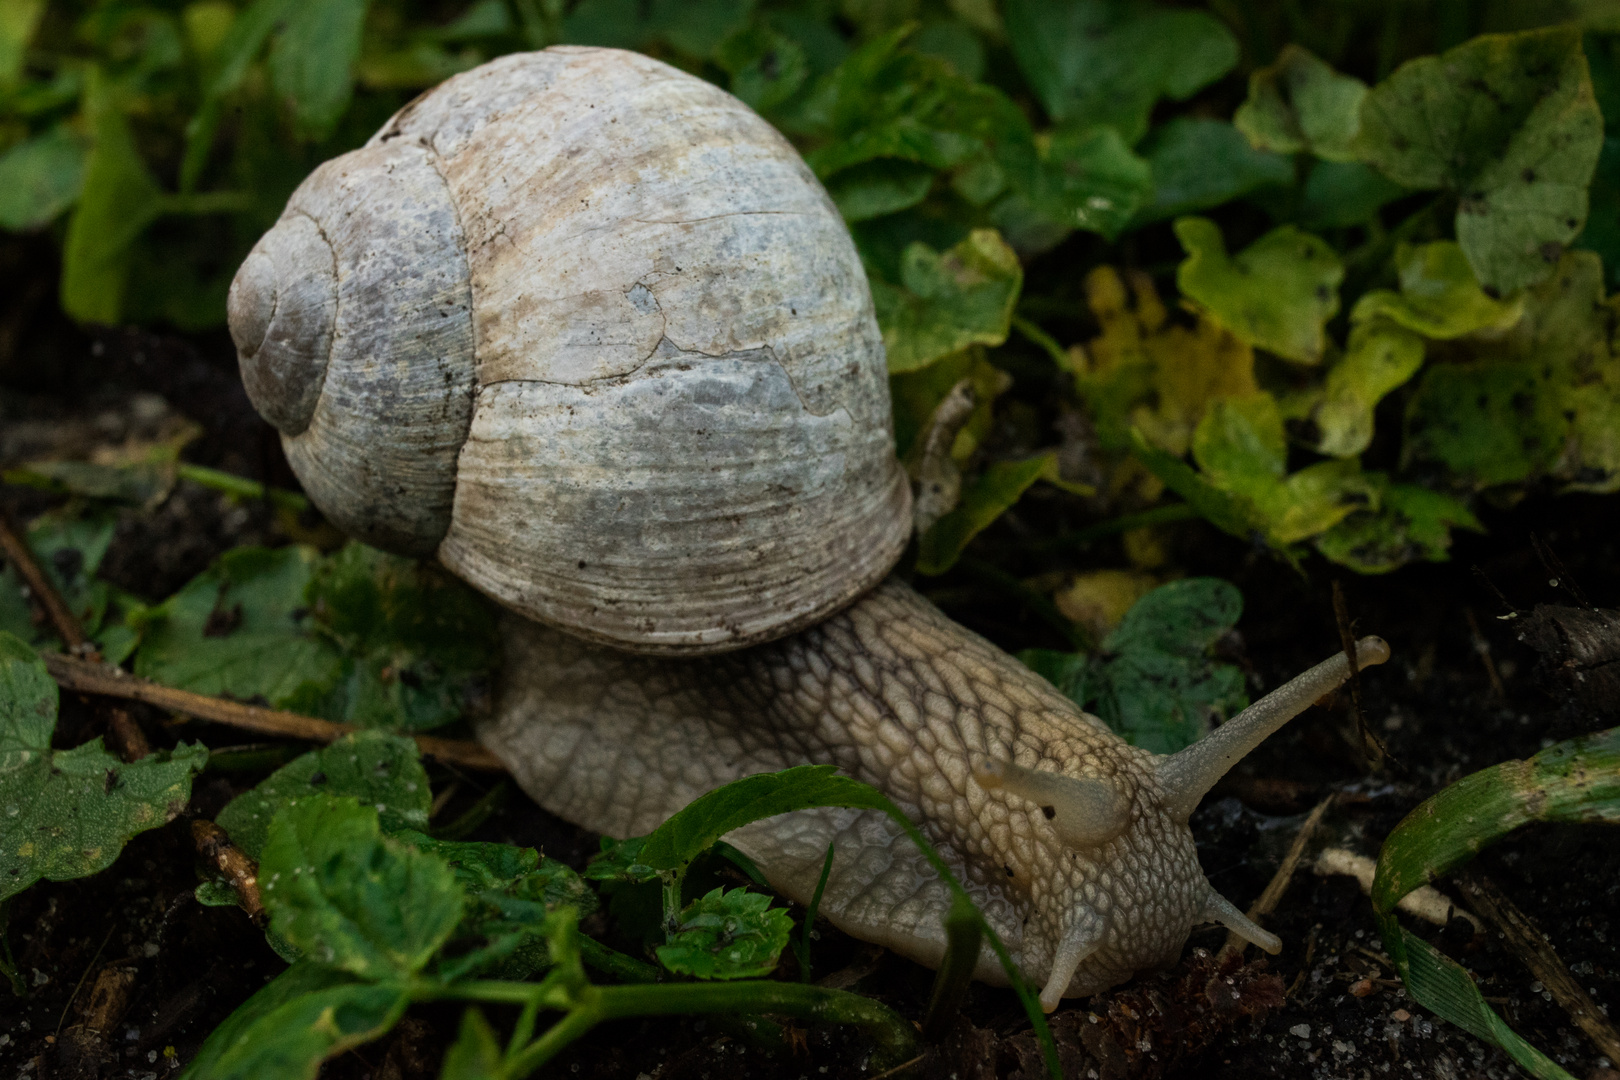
{"left": 480, "top": 580, "right": 1388, "bottom": 1010}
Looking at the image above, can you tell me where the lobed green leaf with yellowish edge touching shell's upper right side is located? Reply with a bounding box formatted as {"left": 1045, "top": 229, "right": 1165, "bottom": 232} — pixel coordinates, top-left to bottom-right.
{"left": 872, "top": 228, "right": 1024, "bottom": 372}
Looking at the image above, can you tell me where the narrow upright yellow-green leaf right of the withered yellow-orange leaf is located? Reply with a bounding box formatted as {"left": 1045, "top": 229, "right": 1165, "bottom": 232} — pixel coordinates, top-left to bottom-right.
{"left": 1312, "top": 318, "right": 1424, "bottom": 457}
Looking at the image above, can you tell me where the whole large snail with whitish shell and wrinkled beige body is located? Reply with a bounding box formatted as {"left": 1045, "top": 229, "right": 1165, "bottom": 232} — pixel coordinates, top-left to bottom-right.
{"left": 228, "top": 47, "right": 1388, "bottom": 1010}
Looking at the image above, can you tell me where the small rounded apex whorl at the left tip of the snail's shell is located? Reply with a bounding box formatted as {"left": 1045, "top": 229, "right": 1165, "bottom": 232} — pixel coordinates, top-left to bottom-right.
{"left": 225, "top": 214, "right": 337, "bottom": 436}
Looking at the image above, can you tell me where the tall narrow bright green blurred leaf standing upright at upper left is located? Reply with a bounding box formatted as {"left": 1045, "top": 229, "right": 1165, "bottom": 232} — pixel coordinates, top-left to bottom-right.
{"left": 62, "top": 68, "right": 164, "bottom": 324}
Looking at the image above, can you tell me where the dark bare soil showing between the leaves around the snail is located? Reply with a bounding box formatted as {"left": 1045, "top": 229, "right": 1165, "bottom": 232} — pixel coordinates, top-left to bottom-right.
{"left": 0, "top": 307, "right": 1620, "bottom": 1080}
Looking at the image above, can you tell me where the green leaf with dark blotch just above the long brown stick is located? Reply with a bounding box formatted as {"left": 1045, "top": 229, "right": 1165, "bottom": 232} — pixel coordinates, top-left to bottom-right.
{"left": 134, "top": 547, "right": 343, "bottom": 708}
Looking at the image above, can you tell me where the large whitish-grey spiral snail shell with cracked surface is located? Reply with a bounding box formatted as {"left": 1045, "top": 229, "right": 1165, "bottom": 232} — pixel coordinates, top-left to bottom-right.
{"left": 228, "top": 47, "right": 910, "bottom": 653}
